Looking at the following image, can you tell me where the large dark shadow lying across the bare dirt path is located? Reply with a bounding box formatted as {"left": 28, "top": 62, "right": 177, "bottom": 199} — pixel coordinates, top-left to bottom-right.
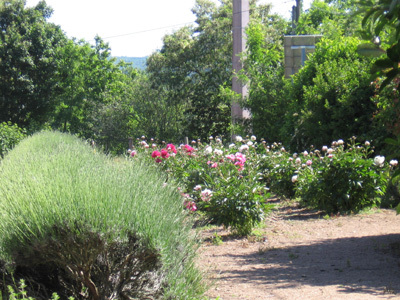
{"left": 219, "top": 234, "right": 400, "bottom": 295}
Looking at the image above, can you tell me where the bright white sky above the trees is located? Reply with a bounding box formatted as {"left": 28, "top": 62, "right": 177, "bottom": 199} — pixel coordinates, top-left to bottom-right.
{"left": 26, "top": 0, "right": 311, "bottom": 57}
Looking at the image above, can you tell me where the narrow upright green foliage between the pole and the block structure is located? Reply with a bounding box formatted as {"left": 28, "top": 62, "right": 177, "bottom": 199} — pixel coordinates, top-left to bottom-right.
{"left": 242, "top": 17, "right": 287, "bottom": 142}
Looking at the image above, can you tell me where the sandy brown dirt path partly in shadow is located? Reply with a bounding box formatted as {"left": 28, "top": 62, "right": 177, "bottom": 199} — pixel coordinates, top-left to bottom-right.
{"left": 200, "top": 203, "right": 400, "bottom": 300}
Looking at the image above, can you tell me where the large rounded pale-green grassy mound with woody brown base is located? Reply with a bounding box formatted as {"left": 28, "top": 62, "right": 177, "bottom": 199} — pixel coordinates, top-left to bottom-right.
{"left": 0, "top": 132, "right": 202, "bottom": 299}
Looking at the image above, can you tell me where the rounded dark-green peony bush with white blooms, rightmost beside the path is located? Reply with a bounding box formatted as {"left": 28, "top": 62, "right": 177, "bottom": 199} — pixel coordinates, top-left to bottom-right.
{"left": 296, "top": 139, "right": 389, "bottom": 213}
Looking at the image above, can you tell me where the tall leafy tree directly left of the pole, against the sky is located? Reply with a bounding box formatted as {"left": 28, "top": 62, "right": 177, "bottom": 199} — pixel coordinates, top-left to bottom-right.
{"left": 147, "top": 0, "right": 284, "bottom": 138}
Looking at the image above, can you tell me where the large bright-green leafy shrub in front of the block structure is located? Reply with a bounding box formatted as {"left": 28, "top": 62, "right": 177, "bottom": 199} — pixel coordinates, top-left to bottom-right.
{"left": 282, "top": 38, "right": 376, "bottom": 151}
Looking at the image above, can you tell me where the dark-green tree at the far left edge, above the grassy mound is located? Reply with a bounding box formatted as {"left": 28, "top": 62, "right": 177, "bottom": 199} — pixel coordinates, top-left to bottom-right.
{"left": 0, "top": 0, "right": 66, "bottom": 128}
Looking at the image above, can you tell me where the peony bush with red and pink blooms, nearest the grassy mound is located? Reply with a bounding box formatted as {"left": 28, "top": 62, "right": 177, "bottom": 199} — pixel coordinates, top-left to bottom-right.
{"left": 131, "top": 137, "right": 270, "bottom": 235}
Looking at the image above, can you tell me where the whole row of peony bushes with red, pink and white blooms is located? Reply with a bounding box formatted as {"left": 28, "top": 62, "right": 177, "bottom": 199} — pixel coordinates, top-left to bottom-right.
{"left": 130, "top": 137, "right": 398, "bottom": 234}
